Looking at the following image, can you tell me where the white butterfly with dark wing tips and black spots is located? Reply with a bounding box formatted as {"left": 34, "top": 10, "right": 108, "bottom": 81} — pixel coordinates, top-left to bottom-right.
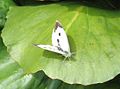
{"left": 34, "top": 21, "right": 72, "bottom": 58}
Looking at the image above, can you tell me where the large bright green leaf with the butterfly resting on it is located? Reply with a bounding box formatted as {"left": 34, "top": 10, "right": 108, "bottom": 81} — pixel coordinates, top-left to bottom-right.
{"left": 2, "top": 3, "right": 120, "bottom": 85}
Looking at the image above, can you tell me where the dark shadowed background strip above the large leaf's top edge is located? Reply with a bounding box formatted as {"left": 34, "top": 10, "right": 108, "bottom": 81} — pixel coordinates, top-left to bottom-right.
{"left": 14, "top": 0, "right": 120, "bottom": 10}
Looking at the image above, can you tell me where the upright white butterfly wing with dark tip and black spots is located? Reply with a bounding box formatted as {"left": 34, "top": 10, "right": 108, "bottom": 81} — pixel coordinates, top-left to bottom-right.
{"left": 52, "top": 21, "right": 70, "bottom": 52}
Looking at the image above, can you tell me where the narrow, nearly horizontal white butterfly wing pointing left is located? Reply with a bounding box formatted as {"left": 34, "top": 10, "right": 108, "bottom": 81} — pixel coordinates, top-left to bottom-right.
{"left": 34, "top": 44, "right": 65, "bottom": 55}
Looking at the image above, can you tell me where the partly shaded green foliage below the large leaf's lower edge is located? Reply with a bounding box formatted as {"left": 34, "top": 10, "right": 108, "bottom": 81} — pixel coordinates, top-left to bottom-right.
{"left": 0, "top": 34, "right": 120, "bottom": 89}
